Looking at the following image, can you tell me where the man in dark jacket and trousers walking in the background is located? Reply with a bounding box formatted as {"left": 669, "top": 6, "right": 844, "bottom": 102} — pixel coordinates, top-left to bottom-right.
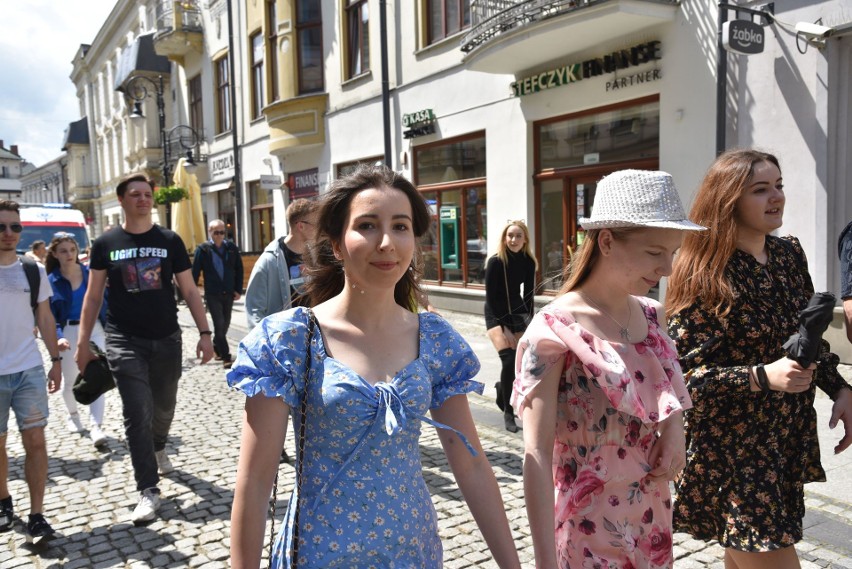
{"left": 192, "top": 219, "right": 243, "bottom": 369}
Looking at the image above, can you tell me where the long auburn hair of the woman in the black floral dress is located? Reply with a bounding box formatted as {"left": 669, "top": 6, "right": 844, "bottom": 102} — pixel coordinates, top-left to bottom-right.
{"left": 666, "top": 149, "right": 781, "bottom": 318}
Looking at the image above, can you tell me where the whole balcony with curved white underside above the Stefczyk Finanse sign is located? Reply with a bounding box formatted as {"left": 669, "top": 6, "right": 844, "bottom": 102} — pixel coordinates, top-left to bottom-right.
{"left": 461, "top": 0, "right": 680, "bottom": 73}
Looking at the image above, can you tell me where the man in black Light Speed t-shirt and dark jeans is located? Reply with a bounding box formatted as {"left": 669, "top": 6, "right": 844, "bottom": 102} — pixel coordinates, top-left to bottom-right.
{"left": 75, "top": 174, "right": 213, "bottom": 524}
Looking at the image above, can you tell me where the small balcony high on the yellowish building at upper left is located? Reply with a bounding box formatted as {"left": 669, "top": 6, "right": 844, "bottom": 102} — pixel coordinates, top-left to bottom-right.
{"left": 154, "top": 0, "right": 204, "bottom": 61}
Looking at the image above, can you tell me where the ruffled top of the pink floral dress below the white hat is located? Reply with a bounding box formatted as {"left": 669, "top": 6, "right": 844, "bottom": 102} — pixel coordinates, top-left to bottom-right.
{"left": 512, "top": 305, "right": 692, "bottom": 423}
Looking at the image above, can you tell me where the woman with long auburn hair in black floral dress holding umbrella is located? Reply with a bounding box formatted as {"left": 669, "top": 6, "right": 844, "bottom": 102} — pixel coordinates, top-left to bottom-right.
{"left": 666, "top": 150, "right": 852, "bottom": 569}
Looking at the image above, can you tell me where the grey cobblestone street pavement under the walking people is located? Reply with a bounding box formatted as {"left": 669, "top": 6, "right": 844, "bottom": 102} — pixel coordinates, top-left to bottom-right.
{"left": 0, "top": 315, "right": 852, "bottom": 569}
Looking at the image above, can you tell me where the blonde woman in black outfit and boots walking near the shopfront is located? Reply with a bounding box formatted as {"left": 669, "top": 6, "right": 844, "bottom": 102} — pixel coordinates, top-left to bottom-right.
{"left": 485, "top": 220, "right": 538, "bottom": 433}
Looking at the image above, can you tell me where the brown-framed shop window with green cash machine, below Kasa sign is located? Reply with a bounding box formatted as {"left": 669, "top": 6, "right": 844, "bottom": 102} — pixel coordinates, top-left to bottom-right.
{"left": 414, "top": 134, "right": 488, "bottom": 286}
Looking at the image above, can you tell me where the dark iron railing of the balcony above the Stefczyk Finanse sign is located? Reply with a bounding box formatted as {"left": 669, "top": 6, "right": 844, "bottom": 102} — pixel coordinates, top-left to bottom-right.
{"left": 461, "top": 0, "right": 679, "bottom": 53}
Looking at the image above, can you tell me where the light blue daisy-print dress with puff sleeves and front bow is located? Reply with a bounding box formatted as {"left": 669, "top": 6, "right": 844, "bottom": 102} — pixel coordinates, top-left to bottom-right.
{"left": 228, "top": 308, "right": 483, "bottom": 568}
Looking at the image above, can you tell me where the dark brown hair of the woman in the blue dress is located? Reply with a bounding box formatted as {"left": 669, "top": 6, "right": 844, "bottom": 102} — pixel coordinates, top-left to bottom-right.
{"left": 306, "top": 164, "right": 431, "bottom": 309}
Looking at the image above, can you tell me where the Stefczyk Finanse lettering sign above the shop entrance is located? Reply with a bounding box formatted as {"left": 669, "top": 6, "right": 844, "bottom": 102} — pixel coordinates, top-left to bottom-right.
{"left": 511, "top": 41, "right": 663, "bottom": 97}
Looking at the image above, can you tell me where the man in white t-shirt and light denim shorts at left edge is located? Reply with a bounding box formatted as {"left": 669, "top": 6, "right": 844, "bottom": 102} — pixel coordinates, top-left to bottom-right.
{"left": 0, "top": 200, "right": 62, "bottom": 543}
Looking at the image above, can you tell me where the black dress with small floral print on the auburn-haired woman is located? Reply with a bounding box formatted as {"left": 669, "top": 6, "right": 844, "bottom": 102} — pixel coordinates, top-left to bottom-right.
{"left": 669, "top": 236, "right": 847, "bottom": 551}
